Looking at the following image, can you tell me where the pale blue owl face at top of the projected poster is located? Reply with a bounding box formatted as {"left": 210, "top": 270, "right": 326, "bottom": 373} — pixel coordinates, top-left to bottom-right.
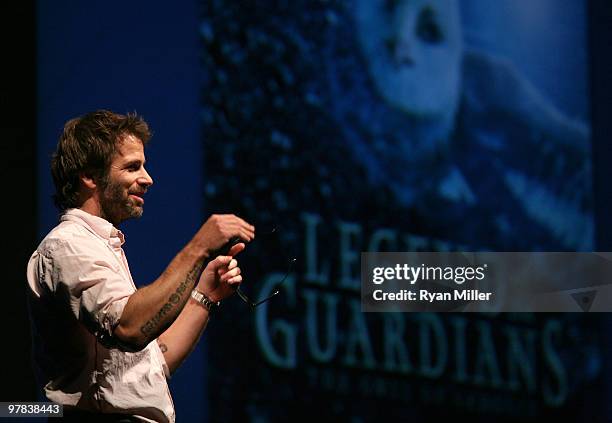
{"left": 355, "top": 0, "right": 462, "bottom": 118}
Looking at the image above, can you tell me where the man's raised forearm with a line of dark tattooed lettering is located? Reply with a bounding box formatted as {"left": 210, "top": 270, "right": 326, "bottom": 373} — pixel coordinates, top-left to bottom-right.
{"left": 115, "top": 245, "right": 205, "bottom": 349}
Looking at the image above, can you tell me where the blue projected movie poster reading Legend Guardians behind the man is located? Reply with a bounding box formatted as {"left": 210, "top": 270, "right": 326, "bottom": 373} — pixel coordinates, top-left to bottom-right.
{"left": 200, "top": 0, "right": 600, "bottom": 421}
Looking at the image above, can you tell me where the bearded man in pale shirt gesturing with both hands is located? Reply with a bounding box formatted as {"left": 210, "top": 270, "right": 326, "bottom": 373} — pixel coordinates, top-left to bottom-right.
{"left": 27, "top": 110, "right": 255, "bottom": 422}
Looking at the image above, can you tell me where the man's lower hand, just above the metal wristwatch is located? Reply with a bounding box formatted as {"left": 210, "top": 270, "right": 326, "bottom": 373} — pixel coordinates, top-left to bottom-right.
{"left": 196, "top": 242, "right": 245, "bottom": 302}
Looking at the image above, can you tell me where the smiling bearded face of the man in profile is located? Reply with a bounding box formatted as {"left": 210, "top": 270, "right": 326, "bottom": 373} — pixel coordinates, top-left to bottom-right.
{"left": 100, "top": 135, "right": 153, "bottom": 226}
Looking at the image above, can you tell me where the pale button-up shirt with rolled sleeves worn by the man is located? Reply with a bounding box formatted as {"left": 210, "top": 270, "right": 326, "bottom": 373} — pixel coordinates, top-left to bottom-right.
{"left": 27, "top": 209, "right": 175, "bottom": 422}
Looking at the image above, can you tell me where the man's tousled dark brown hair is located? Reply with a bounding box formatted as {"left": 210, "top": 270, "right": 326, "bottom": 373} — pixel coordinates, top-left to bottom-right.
{"left": 51, "top": 110, "right": 151, "bottom": 211}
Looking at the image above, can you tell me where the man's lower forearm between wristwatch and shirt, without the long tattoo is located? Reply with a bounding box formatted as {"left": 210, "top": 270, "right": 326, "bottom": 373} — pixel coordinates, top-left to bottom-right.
{"left": 157, "top": 300, "right": 209, "bottom": 373}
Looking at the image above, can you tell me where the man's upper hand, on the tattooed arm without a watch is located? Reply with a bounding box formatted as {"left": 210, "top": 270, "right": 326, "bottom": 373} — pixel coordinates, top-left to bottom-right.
{"left": 192, "top": 214, "right": 255, "bottom": 257}
